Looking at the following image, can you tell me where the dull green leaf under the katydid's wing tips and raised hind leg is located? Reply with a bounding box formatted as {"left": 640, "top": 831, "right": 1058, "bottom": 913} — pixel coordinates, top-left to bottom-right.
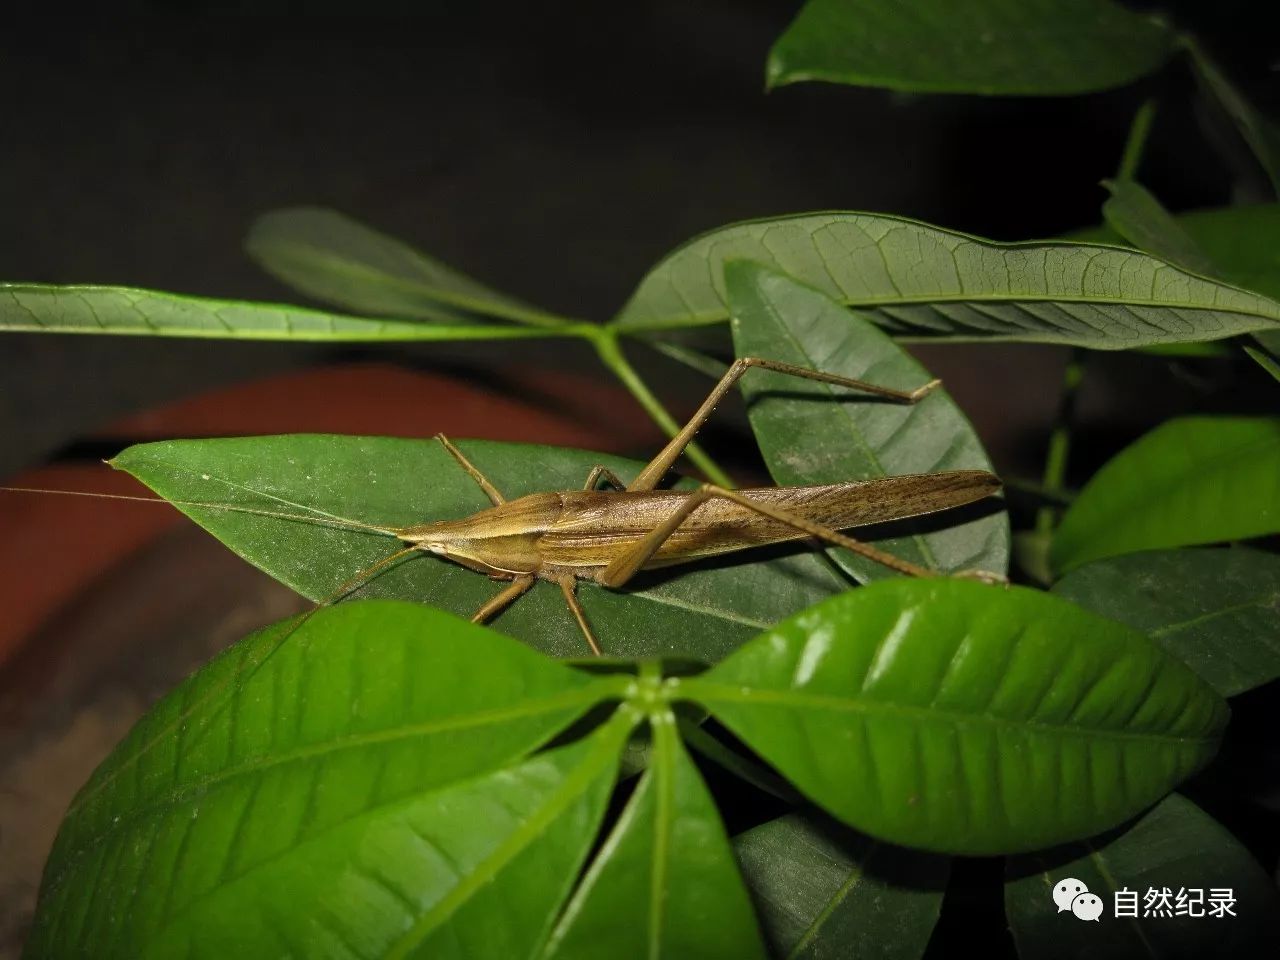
{"left": 724, "top": 260, "right": 1009, "bottom": 582}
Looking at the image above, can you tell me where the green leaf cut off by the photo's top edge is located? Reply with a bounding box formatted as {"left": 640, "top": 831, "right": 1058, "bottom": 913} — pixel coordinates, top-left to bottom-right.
{"left": 768, "top": 0, "right": 1174, "bottom": 96}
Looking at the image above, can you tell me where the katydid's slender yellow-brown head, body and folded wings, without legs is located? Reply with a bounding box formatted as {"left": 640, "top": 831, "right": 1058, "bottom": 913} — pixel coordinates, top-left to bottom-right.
{"left": 401, "top": 470, "right": 1000, "bottom": 580}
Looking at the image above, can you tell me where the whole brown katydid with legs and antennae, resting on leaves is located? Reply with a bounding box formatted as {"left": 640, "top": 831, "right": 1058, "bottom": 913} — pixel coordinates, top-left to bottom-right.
{"left": 2, "top": 357, "right": 1001, "bottom": 654}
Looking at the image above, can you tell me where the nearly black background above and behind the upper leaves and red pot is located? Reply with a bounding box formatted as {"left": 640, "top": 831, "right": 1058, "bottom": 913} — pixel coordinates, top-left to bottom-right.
{"left": 0, "top": 0, "right": 1275, "bottom": 475}
